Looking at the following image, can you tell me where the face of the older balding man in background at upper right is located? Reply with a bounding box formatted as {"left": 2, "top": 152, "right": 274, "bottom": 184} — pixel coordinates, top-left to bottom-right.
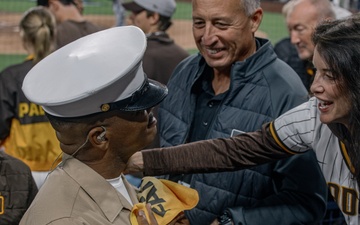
{"left": 286, "top": 1, "right": 318, "bottom": 60}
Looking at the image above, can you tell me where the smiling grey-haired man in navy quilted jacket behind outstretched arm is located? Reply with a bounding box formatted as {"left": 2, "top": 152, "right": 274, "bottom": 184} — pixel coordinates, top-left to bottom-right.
{"left": 159, "top": 0, "right": 326, "bottom": 225}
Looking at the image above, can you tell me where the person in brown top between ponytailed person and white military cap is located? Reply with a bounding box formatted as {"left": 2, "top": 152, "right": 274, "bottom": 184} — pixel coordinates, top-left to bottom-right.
{"left": 37, "top": 0, "right": 102, "bottom": 48}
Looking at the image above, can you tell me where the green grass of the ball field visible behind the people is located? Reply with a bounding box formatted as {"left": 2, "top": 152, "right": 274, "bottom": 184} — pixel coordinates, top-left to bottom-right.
{"left": 0, "top": 0, "right": 287, "bottom": 70}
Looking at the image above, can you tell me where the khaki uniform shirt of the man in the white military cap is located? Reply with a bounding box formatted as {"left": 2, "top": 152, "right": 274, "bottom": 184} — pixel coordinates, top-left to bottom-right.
{"left": 20, "top": 156, "right": 138, "bottom": 225}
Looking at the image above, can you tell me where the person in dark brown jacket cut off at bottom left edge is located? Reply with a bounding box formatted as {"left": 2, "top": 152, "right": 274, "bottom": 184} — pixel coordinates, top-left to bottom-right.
{"left": 0, "top": 148, "right": 38, "bottom": 225}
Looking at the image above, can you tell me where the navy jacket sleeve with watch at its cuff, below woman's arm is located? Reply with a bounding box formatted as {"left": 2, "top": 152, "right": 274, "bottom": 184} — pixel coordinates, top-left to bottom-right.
{"left": 227, "top": 151, "right": 327, "bottom": 225}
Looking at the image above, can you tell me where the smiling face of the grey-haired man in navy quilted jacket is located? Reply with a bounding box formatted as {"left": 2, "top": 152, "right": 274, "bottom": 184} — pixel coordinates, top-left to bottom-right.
{"left": 192, "top": 0, "right": 262, "bottom": 70}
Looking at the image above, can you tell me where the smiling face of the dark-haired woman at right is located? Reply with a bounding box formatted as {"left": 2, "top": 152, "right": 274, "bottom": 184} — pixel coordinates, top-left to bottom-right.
{"left": 310, "top": 48, "right": 351, "bottom": 126}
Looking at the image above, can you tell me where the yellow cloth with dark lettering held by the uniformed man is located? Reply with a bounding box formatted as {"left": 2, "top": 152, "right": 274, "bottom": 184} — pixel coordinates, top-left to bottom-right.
{"left": 130, "top": 177, "right": 199, "bottom": 225}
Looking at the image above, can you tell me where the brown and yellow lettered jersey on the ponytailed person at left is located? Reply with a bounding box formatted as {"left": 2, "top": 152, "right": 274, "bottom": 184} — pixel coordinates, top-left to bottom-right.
{"left": 0, "top": 58, "right": 61, "bottom": 171}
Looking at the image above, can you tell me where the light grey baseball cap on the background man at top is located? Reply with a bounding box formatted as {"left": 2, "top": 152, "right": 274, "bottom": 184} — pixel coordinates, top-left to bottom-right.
{"left": 123, "top": 0, "right": 176, "bottom": 17}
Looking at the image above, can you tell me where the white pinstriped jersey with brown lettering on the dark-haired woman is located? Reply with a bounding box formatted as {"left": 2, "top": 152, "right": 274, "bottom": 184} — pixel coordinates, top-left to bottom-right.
{"left": 270, "top": 98, "right": 359, "bottom": 225}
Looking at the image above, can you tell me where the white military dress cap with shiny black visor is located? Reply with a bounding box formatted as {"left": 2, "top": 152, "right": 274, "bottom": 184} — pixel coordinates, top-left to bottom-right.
{"left": 22, "top": 26, "right": 167, "bottom": 118}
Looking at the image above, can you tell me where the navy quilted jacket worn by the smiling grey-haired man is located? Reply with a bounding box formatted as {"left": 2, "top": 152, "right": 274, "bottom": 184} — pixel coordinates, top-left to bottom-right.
{"left": 159, "top": 39, "right": 327, "bottom": 225}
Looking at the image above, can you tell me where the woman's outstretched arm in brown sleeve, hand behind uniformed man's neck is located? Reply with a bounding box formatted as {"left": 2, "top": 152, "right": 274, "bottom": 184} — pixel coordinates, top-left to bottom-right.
{"left": 127, "top": 123, "right": 291, "bottom": 175}
